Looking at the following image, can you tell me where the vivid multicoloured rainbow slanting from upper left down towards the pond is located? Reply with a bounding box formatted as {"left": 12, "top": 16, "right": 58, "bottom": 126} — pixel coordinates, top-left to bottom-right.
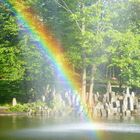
{"left": 1, "top": 0, "right": 95, "bottom": 119}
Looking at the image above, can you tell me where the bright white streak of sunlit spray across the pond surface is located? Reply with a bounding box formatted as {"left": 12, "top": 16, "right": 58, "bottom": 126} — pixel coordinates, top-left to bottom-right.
{"left": 15, "top": 123, "right": 140, "bottom": 133}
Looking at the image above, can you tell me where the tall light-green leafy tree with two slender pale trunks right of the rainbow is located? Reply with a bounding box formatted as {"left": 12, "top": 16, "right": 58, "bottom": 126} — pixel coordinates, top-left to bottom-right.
{"left": 52, "top": 0, "right": 118, "bottom": 105}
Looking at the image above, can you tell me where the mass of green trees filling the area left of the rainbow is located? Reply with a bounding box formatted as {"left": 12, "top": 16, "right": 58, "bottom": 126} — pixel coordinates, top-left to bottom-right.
{"left": 0, "top": 1, "right": 54, "bottom": 102}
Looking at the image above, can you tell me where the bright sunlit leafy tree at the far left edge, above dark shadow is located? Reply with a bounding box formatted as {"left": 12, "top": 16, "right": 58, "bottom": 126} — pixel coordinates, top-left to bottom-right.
{"left": 0, "top": 4, "right": 24, "bottom": 80}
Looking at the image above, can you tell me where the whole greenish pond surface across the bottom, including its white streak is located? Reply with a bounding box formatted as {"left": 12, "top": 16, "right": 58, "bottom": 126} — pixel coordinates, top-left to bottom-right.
{"left": 0, "top": 116, "right": 140, "bottom": 140}
